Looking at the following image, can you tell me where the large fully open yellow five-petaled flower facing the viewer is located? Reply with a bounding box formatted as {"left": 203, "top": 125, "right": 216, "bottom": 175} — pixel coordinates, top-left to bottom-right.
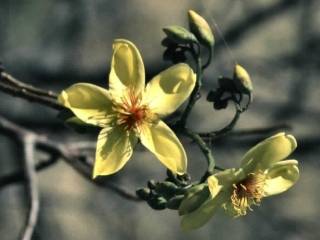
{"left": 59, "top": 39, "right": 196, "bottom": 177}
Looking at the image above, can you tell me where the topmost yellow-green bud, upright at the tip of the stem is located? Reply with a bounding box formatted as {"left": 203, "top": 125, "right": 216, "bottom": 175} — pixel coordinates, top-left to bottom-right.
{"left": 188, "top": 10, "right": 214, "bottom": 47}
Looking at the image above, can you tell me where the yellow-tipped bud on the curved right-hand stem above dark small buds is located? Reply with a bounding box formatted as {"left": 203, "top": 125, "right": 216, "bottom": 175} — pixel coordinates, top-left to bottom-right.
{"left": 233, "top": 64, "right": 253, "bottom": 94}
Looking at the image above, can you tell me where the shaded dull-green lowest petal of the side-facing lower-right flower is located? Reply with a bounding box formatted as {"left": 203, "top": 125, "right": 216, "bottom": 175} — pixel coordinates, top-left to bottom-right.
{"left": 181, "top": 194, "right": 226, "bottom": 231}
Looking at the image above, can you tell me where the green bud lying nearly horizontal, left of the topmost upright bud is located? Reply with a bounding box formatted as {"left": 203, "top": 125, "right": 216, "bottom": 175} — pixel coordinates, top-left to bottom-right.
{"left": 163, "top": 26, "right": 198, "bottom": 44}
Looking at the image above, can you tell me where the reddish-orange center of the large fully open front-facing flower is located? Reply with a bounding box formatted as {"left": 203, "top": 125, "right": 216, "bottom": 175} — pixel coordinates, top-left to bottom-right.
{"left": 114, "top": 93, "right": 150, "bottom": 131}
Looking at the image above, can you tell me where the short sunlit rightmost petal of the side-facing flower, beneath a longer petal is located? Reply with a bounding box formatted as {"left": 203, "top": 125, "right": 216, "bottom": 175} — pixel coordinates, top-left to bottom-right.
{"left": 264, "top": 160, "right": 299, "bottom": 196}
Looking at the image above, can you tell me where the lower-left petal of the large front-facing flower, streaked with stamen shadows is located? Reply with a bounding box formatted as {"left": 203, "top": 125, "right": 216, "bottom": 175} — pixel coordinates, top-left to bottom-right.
{"left": 93, "top": 128, "right": 136, "bottom": 178}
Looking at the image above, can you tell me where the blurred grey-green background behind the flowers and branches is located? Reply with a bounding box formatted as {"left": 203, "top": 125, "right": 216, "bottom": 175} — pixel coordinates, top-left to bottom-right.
{"left": 0, "top": 0, "right": 320, "bottom": 240}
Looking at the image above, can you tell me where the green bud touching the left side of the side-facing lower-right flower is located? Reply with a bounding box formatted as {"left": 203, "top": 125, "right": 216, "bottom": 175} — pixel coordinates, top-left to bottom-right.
{"left": 179, "top": 184, "right": 210, "bottom": 216}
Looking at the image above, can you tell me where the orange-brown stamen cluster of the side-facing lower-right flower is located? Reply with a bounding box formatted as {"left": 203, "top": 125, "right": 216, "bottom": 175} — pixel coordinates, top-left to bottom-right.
{"left": 231, "top": 171, "right": 266, "bottom": 216}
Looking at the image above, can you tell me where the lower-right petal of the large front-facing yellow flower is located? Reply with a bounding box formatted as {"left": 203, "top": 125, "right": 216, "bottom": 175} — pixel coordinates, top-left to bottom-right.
{"left": 140, "top": 121, "right": 187, "bottom": 174}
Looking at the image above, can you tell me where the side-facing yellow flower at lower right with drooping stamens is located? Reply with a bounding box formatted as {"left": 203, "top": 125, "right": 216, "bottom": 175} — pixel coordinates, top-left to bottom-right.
{"left": 180, "top": 133, "right": 299, "bottom": 230}
